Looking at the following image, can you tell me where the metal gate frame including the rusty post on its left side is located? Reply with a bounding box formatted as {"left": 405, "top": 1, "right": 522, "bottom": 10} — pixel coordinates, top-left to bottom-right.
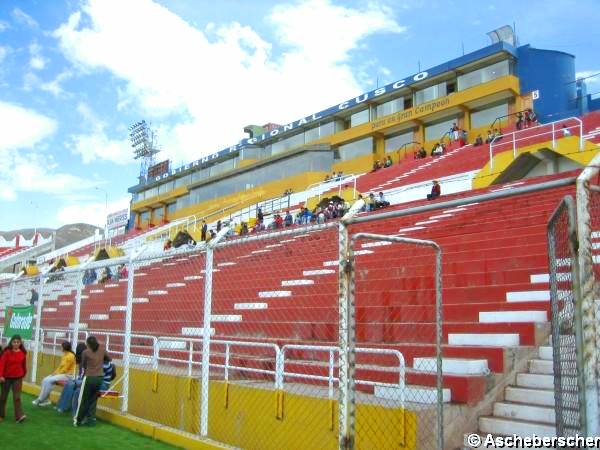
{"left": 338, "top": 230, "right": 444, "bottom": 450}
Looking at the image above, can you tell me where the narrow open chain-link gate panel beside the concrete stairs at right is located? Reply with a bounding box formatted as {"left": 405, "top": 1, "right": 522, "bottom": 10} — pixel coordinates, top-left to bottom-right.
{"left": 547, "top": 196, "right": 586, "bottom": 436}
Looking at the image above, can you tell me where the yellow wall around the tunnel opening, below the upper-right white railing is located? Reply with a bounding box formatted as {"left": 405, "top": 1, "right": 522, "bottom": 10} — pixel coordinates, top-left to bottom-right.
{"left": 473, "top": 136, "right": 598, "bottom": 189}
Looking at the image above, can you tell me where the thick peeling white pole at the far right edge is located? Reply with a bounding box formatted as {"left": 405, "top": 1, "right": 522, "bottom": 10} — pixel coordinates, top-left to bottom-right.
{"left": 577, "top": 167, "right": 600, "bottom": 436}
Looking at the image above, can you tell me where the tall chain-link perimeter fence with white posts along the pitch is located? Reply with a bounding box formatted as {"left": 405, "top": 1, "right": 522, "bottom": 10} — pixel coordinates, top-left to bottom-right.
{"left": 0, "top": 217, "right": 443, "bottom": 449}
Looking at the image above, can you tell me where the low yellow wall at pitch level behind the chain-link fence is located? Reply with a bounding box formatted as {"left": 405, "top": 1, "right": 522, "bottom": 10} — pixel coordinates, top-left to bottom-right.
{"left": 32, "top": 355, "right": 418, "bottom": 450}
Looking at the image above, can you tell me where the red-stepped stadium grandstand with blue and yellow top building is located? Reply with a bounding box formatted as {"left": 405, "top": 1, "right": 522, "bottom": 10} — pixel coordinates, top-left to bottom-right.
{"left": 0, "top": 28, "right": 600, "bottom": 449}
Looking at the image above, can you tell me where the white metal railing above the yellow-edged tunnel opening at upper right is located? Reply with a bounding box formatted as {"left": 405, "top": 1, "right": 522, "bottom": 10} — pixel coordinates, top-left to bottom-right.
{"left": 490, "top": 117, "right": 583, "bottom": 170}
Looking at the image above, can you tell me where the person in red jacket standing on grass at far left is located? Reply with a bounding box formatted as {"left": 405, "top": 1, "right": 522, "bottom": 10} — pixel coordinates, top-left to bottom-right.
{"left": 0, "top": 334, "right": 27, "bottom": 423}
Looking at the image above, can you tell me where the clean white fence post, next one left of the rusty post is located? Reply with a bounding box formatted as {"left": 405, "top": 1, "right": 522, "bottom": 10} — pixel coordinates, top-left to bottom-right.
{"left": 200, "top": 245, "right": 214, "bottom": 436}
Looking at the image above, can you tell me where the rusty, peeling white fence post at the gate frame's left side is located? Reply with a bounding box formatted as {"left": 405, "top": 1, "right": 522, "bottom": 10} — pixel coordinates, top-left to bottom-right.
{"left": 338, "top": 222, "right": 356, "bottom": 450}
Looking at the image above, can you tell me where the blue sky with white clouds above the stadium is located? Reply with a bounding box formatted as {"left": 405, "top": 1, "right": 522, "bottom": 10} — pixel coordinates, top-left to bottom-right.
{"left": 0, "top": 0, "right": 600, "bottom": 230}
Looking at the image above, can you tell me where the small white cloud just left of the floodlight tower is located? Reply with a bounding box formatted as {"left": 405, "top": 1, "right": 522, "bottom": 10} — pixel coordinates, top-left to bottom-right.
{"left": 68, "top": 103, "right": 133, "bottom": 164}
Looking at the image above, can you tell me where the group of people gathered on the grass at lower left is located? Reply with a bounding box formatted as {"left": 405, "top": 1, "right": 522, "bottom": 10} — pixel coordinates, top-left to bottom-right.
{"left": 0, "top": 335, "right": 117, "bottom": 427}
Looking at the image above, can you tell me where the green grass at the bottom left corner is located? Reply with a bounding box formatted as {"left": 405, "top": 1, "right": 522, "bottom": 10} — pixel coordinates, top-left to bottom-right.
{"left": 0, "top": 394, "right": 175, "bottom": 450}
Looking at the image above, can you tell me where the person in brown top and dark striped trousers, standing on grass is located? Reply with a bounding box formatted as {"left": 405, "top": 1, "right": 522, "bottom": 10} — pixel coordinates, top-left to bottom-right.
{"left": 73, "top": 336, "right": 106, "bottom": 427}
